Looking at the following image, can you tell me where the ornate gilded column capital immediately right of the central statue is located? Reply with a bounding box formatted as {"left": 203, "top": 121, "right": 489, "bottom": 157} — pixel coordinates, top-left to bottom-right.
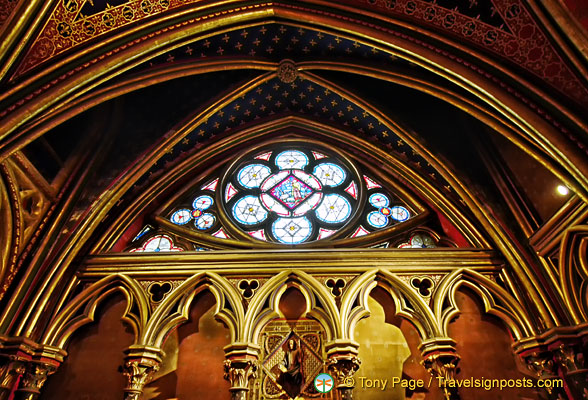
{"left": 325, "top": 340, "right": 361, "bottom": 400}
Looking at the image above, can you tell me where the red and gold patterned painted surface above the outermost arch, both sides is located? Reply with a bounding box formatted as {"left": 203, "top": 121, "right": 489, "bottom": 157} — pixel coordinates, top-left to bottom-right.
{"left": 9, "top": 0, "right": 588, "bottom": 104}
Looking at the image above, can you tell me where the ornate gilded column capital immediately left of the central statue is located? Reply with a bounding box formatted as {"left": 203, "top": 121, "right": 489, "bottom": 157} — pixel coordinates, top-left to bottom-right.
{"left": 224, "top": 343, "right": 259, "bottom": 400}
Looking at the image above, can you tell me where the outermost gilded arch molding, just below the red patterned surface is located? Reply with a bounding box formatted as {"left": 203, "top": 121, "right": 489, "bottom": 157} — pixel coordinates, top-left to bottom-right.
{"left": 0, "top": 3, "right": 586, "bottom": 196}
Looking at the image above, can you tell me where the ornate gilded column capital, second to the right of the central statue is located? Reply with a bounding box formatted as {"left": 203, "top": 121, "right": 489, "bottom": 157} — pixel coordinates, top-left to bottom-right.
{"left": 419, "top": 338, "right": 460, "bottom": 400}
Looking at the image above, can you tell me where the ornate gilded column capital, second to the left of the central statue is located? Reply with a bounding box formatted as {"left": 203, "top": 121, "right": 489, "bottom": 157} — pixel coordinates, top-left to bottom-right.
{"left": 123, "top": 345, "right": 163, "bottom": 400}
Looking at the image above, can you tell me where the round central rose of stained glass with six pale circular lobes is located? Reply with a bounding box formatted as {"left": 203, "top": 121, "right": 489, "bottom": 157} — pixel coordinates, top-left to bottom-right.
{"left": 223, "top": 146, "right": 359, "bottom": 244}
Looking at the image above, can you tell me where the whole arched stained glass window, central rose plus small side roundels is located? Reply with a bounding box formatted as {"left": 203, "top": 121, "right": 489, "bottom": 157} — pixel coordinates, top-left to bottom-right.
{"left": 166, "top": 140, "right": 418, "bottom": 246}
